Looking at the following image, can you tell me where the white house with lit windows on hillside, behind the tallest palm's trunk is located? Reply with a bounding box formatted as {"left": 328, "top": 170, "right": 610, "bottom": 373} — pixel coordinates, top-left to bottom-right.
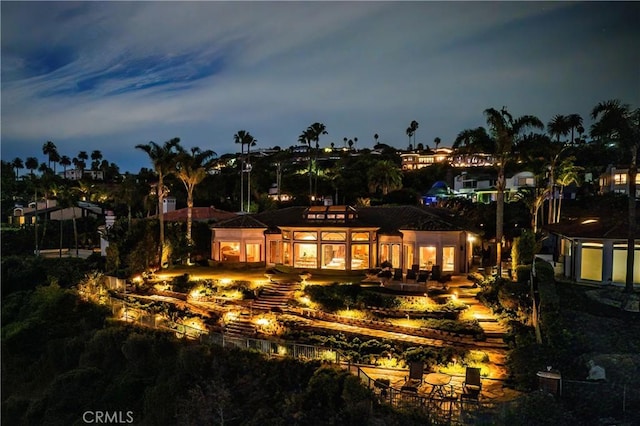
{"left": 453, "top": 170, "right": 536, "bottom": 203}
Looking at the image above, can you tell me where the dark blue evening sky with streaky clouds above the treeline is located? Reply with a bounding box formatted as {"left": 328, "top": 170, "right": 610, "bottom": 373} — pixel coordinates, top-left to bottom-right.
{"left": 0, "top": 1, "right": 640, "bottom": 172}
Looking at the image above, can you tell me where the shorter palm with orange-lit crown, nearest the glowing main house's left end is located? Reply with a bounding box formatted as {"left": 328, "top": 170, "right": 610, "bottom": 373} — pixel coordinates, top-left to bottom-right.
{"left": 176, "top": 147, "right": 217, "bottom": 244}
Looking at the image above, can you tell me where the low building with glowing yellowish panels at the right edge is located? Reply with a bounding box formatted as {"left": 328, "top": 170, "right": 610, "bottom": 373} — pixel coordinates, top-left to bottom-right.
{"left": 545, "top": 217, "right": 640, "bottom": 285}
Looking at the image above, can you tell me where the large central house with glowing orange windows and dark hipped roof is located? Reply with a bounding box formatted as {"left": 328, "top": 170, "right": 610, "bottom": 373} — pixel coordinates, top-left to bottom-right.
{"left": 211, "top": 206, "right": 473, "bottom": 274}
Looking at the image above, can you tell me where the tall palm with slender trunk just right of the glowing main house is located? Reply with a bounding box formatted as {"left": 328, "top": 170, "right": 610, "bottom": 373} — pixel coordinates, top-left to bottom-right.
{"left": 453, "top": 107, "right": 544, "bottom": 276}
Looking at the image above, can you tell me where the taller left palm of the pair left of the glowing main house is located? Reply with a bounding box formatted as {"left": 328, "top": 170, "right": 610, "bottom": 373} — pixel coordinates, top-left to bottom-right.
{"left": 136, "top": 138, "right": 180, "bottom": 268}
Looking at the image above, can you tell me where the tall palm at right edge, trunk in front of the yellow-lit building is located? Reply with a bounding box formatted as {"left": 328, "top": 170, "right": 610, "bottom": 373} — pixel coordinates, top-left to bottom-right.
{"left": 591, "top": 99, "right": 640, "bottom": 294}
